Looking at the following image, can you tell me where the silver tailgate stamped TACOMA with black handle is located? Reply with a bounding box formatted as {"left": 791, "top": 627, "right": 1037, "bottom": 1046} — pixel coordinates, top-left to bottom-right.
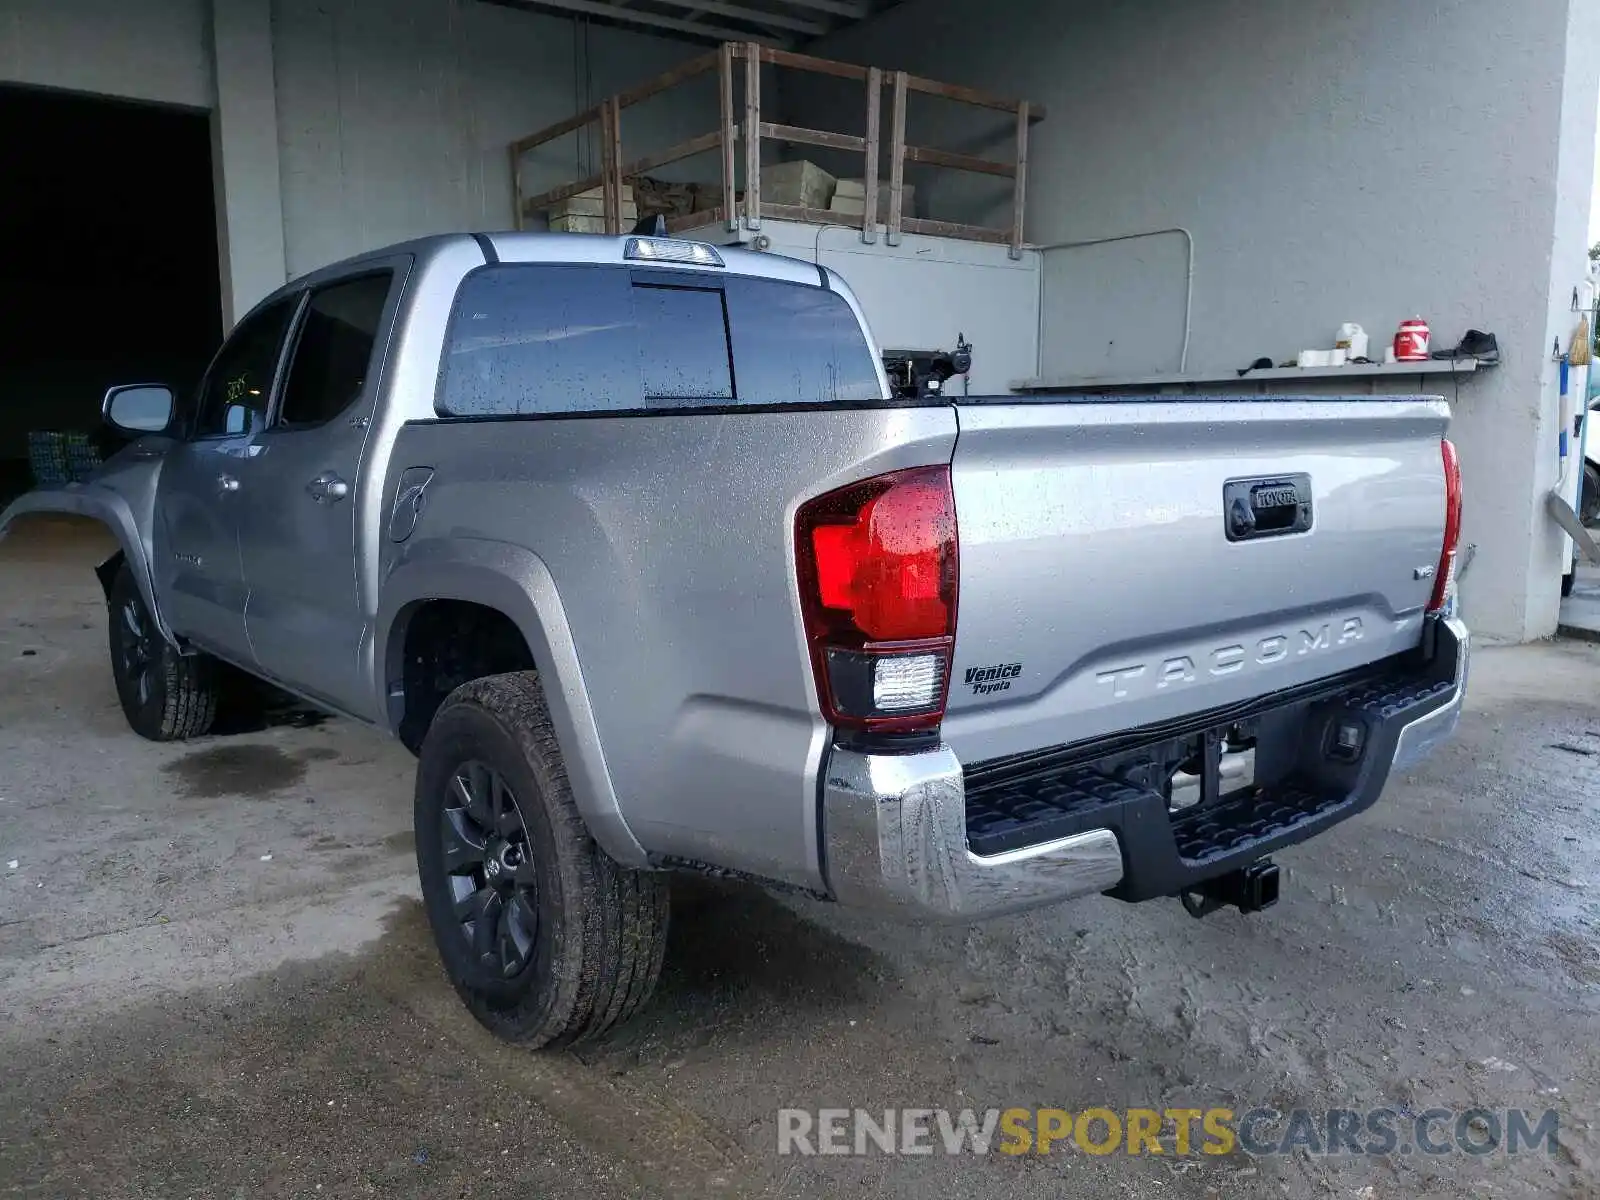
{"left": 942, "top": 397, "right": 1450, "bottom": 763}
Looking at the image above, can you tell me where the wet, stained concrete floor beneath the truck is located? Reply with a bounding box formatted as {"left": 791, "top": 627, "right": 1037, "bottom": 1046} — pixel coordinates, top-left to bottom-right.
{"left": 0, "top": 523, "right": 1600, "bottom": 1200}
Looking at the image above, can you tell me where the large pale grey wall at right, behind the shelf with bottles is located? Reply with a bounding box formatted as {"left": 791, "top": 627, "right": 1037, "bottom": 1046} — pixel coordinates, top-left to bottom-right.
{"left": 806, "top": 0, "right": 1600, "bottom": 638}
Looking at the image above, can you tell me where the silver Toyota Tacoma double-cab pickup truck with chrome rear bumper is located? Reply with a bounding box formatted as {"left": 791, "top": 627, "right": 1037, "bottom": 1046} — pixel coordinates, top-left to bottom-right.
{"left": 0, "top": 234, "right": 1467, "bottom": 1045}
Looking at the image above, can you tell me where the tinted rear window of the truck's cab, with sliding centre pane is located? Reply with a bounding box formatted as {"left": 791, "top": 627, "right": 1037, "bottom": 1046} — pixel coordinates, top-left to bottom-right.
{"left": 437, "top": 266, "right": 882, "bottom": 416}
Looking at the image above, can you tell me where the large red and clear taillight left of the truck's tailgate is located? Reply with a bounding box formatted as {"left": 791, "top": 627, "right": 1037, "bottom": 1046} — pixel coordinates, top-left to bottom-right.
{"left": 795, "top": 467, "right": 958, "bottom": 731}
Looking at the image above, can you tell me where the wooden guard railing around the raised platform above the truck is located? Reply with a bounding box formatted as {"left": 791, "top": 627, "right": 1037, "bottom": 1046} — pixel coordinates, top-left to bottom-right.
{"left": 509, "top": 42, "right": 1045, "bottom": 256}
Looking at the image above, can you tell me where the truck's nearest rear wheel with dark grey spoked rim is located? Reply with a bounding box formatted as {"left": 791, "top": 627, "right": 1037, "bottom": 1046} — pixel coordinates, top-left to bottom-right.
{"left": 414, "top": 672, "right": 667, "bottom": 1046}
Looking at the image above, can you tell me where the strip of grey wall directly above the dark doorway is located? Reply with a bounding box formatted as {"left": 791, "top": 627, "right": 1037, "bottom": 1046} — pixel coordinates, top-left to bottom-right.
{"left": 0, "top": 0, "right": 211, "bottom": 109}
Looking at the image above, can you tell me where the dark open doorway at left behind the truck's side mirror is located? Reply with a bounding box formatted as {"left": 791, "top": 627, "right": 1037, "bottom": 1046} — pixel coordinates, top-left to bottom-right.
{"left": 0, "top": 88, "right": 222, "bottom": 498}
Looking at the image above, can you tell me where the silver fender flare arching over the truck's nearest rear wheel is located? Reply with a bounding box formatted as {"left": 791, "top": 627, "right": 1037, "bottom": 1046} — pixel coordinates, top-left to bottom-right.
{"left": 373, "top": 538, "right": 648, "bottom": 866}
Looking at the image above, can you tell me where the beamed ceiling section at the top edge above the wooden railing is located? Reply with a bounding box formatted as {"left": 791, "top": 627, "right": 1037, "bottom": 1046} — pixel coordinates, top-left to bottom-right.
{"left": 490, "top": 0, "right": 898, "bottom": 46}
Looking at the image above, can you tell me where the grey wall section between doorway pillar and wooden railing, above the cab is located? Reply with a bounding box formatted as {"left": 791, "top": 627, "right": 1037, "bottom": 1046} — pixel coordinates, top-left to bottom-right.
{"left": 274, "top": 0, "right": 717, "bottom": 275}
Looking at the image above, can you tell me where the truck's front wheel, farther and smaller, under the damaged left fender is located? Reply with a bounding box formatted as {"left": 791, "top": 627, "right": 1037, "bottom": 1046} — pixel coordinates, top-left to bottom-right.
{"left": 107, "top": 563, "right": 218, "bottom": 742}
